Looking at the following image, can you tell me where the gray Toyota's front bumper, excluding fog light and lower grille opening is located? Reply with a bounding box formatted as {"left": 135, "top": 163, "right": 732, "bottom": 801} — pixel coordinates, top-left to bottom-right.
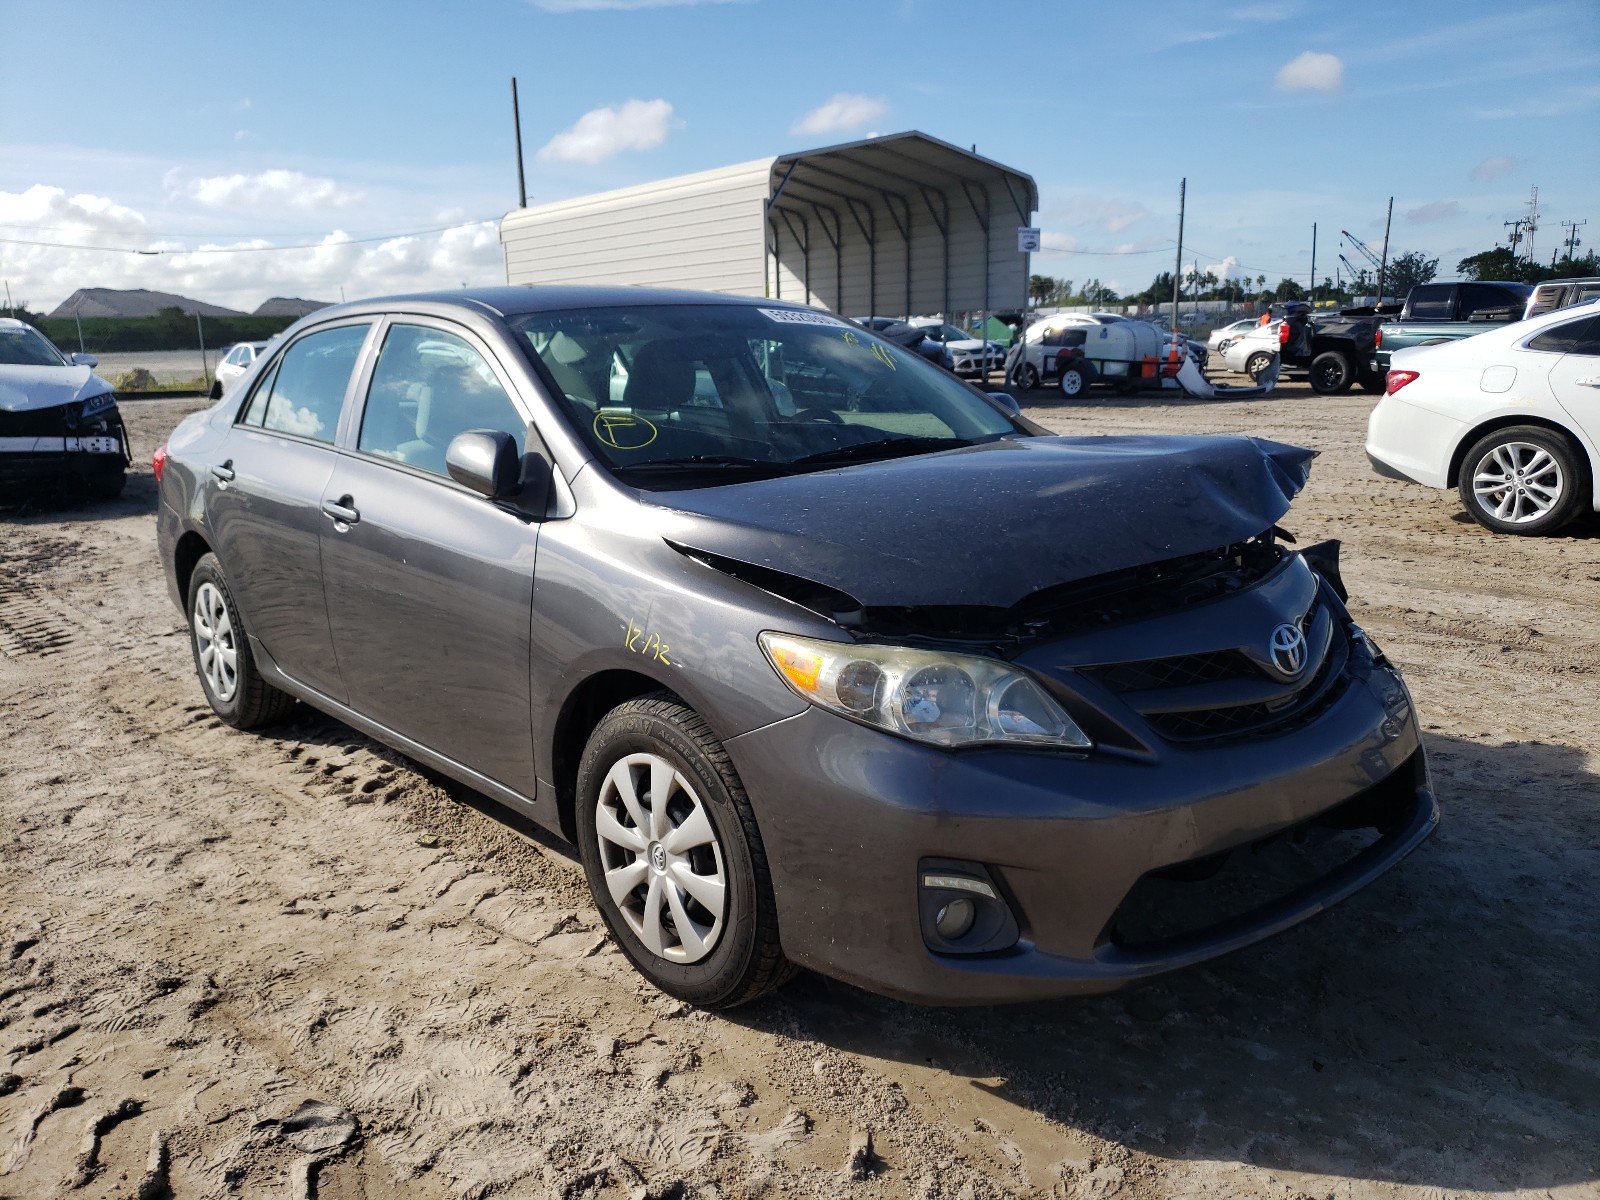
{"left": 728, "top": 652, "right": 1438, "bottom": 1005}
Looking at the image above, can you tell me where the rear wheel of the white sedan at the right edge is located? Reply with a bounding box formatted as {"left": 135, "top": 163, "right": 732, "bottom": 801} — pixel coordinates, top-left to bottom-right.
{"left": 1456, "top": 426, "right": 1589, "bottom": 538}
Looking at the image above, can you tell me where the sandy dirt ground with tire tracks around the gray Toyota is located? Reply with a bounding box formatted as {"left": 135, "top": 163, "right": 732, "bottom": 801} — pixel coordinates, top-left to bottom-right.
{"left": 0, "top": 386, "right": 1600, "bottom": 1200}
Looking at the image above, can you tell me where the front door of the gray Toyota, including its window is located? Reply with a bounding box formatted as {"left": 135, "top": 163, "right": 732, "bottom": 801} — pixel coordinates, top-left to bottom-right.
{"left": 322, "top": 318, "right": 539, "bottom": 797}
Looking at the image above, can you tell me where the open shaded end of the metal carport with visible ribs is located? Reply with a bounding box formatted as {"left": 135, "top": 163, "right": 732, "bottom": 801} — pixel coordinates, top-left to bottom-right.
{"left": 766, "top": 131, "right": 1038, "bottom": 317}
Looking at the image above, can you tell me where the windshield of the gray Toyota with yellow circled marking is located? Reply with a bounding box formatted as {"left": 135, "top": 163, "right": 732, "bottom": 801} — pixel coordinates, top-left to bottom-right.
{"left": 512, "top": 304, "right": 1019, "bottom": 486}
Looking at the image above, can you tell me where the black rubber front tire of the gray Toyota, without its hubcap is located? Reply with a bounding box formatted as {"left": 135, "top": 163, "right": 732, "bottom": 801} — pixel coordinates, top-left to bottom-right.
{"left": 576, "top": 691, "right": 794, "bottom": 1008}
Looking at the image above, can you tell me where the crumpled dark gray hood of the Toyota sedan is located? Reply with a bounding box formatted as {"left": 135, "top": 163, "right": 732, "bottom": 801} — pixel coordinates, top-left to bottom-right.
{"left": 651, "top": 437, "right": 1315, "bottom": 608}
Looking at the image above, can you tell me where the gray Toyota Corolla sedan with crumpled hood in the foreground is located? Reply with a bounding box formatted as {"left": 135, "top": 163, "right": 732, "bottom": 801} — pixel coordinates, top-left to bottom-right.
{"left": 157, "top": 288, "right": 1438, "bottom": 1006}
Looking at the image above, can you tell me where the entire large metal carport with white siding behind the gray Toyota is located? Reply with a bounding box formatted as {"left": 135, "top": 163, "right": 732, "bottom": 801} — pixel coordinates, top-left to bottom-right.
{"left": 501, "top": 131, "right": 1038, "bottom": 317}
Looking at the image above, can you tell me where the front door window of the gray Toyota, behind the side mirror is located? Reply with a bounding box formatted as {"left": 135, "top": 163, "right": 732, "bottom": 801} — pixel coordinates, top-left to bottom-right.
{"left": 357, "top": 325, "right": 526, "bottom": 477}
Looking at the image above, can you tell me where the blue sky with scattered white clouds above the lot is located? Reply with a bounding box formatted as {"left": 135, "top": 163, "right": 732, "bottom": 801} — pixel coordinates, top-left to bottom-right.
{"left": 0, "top": 0, "right": 1600, "bottom": 309}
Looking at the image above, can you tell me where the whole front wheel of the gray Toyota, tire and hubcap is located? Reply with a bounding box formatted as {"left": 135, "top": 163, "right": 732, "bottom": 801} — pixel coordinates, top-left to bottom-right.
{"left": 576, "top": 693, "right": 794, "bottom": 1008}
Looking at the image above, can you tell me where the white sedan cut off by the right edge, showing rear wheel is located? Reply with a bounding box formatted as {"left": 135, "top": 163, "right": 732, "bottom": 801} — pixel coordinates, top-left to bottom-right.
{"left": 1366, "top": 301, "right": 1600, "bottom": 534}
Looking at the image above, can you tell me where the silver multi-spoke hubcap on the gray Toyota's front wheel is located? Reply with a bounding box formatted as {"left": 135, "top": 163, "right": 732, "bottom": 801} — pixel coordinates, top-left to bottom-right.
{"left": 595, "top": 754, "right": 728, "bottom": 963}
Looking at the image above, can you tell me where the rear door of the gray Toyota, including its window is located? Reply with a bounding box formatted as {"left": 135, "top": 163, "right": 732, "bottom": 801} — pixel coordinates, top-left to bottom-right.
{"left": 203, "top": 318, "right": 373, "bottom": 701}
